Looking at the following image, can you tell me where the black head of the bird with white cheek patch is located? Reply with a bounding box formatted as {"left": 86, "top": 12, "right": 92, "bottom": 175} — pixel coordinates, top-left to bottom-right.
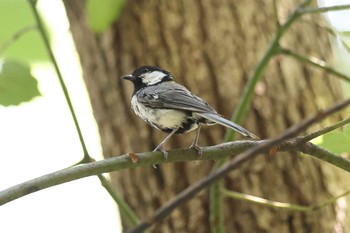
{"left": 122, "top": 66, "right": 173, "bottom": 91}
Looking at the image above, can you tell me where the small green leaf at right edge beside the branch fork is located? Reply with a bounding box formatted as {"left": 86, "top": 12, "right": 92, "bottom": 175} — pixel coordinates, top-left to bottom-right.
{"left": 317, "top": 132, "right": 350, "bottom": 154}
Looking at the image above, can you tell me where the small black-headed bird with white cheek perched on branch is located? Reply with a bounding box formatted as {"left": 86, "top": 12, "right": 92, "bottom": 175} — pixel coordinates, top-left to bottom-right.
{"left": 122, "top": 66, "right": 258, "bottom": 157}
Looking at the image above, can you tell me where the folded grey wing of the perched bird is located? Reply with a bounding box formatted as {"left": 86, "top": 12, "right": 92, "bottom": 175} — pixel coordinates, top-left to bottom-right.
{"left": 137, "top": 82, "right": 216, "bottom": 113}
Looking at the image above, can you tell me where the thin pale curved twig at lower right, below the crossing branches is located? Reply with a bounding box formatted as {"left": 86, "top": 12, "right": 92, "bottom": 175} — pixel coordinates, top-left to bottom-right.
{"left": 221, "top": 189, "right": 350, "bottom": 212}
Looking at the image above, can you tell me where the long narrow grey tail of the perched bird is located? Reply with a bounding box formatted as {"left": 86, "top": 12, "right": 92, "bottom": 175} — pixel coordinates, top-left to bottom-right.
{"left": 196, "top": 112, "right": 259, "bottom": 139}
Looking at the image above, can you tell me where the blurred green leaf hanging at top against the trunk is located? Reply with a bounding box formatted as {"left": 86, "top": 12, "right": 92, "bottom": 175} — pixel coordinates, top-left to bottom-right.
{"left": 86, "top": 0, "right": 125, "bottom": 33}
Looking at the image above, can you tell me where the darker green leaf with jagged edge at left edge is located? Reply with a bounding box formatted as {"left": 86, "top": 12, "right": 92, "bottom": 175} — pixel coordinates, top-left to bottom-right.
{"left": 0, "top": 61, "right": 40, "bottom": 106}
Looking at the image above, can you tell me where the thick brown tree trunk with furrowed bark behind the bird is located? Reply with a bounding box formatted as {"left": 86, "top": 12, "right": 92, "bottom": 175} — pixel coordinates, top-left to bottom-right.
{"left": 64, "top": 0, "right": 349, "bottom": 233}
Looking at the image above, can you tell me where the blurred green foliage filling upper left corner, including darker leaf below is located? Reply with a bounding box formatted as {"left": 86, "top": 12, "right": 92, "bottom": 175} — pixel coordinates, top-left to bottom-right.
{"left": 0, "top": 1, "right": 48, "bottom": 106}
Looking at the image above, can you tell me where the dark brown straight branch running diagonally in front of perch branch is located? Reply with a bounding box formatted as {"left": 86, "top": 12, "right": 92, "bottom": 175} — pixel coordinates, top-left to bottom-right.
{"left": 128, "top": 100, "right": 350, "bottom": 233}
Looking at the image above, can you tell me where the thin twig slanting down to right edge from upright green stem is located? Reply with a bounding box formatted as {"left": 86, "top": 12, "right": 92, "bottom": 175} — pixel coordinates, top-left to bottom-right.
{"left": 279, "top": 48, "right": 350, "bottom": 82}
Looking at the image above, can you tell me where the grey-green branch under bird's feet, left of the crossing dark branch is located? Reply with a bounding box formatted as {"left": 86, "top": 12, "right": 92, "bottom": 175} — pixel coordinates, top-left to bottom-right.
{"left": 0, "top": 141, "right": 252, "bottom": 205}
